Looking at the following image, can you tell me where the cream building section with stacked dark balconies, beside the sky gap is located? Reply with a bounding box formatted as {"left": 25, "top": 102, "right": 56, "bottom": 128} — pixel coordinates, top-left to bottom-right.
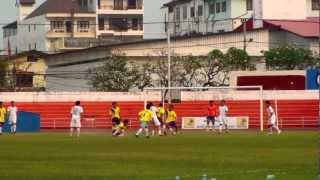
{"left": 97, "top": 0, "right": 144, "bottom": 39}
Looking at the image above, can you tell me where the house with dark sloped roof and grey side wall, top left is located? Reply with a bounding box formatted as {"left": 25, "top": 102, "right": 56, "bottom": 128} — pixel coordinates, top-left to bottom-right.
{"left": 3, "top": 0, "right": 96, "bottom": 53}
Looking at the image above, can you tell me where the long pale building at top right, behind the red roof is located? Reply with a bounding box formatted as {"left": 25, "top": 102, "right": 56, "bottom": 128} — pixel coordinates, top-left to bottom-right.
{"left": 164, "top": 0, "right": 320, "bottom": 36}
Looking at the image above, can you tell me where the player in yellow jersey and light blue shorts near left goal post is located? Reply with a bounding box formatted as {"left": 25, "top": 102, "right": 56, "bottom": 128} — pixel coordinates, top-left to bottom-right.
{"left": 136, "top": 103, "right": 152, "bottom": 138}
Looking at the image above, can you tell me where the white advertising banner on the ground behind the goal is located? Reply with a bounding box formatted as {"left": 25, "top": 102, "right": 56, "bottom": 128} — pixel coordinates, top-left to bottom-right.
{"left": 182, "top": 116, "right": 249, "bottom": 129}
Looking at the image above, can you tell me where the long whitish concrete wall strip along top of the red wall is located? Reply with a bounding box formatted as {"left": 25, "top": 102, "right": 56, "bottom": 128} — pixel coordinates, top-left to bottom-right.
{"left": 0, "top": 90, "right": 319, "bottom": 102}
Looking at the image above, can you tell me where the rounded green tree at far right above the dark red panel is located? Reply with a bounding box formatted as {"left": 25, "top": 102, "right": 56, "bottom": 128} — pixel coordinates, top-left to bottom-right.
{"left": 264, "top": 46, "right": 319, "bottom": 70}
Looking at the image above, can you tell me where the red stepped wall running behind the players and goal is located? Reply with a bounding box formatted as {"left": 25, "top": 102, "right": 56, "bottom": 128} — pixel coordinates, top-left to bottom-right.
{"left": 10, "top": 100, "right": 318, "bottom": 129}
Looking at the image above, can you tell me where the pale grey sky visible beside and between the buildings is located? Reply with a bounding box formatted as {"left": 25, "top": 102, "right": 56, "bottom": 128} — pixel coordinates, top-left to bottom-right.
{"left": 0, "top": 0, "right": 170, "bottom": 49}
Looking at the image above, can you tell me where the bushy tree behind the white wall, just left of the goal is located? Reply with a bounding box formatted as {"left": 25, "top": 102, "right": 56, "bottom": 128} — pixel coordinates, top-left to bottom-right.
{"left": 89, "top": 54, "right": 139, "bottom": 91}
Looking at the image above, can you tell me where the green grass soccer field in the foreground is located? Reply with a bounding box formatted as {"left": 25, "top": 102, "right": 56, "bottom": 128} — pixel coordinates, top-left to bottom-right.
{"left": 0, "top": 131, "right": 318, "bottom": 180}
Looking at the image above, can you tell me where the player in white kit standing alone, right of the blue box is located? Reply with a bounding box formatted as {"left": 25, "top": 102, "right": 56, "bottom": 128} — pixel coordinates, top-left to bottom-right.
{"left": 70, "top": 101, "right": 83, "bottom": 137}
